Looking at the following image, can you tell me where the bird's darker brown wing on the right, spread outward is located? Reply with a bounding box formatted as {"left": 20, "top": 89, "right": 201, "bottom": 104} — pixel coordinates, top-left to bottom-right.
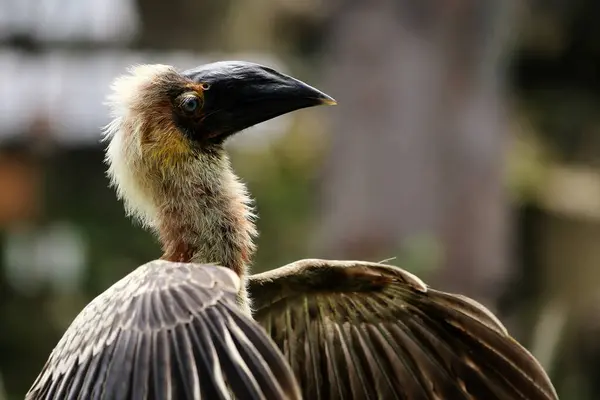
{"left": 249, "top": 260, "right": 557, "bottom": 400}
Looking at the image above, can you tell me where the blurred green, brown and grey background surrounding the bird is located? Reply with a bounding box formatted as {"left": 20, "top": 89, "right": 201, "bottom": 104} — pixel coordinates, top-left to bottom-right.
{"left": 0, "top": 0, "right": 600, "bottom": 400}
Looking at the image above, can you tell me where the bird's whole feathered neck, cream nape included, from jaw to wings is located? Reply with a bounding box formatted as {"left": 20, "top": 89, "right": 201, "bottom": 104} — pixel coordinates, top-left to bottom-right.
{"left": 106, "top": 125, "right": 257, "bottom": 278}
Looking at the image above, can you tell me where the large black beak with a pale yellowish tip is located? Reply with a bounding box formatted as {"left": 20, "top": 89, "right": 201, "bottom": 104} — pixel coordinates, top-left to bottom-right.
{"left": 183, "top": 61, "right": 336, "bottom": 140}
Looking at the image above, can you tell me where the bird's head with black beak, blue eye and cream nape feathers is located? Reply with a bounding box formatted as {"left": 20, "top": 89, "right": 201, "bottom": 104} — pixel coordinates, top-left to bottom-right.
{"left": 105, "top": 61, "right": 335, "bottom": 227}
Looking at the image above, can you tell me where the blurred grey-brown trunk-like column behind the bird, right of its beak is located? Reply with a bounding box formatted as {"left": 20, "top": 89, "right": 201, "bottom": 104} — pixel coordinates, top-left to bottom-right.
{"left": 315, "top": 0, "right": 511, "bottom": 306}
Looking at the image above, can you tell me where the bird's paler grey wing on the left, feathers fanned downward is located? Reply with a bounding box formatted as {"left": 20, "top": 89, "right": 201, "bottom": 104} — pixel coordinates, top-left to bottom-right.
{"left": 26, "top": 261, "right": 300, "bottom": 400}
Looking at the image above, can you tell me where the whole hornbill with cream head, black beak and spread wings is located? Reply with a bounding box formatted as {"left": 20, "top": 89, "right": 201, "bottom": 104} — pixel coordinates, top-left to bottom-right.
{"left": 26, "top": 61, "right": 557, "bottom": 399}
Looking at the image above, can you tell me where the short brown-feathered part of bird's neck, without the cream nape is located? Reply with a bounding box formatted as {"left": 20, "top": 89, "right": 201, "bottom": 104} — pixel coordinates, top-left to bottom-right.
{"left": 155, "top": 152, "right": 256, "bottom": 282}
